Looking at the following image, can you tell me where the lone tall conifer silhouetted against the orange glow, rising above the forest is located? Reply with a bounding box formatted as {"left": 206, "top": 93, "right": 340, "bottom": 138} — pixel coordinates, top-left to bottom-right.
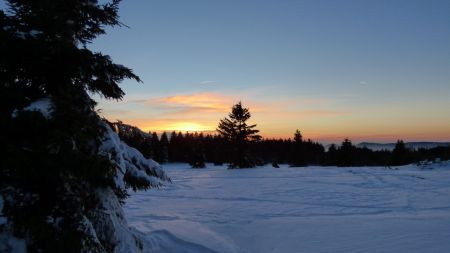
{"left": 217, "top": 102, "right": 261, "bottom": 168}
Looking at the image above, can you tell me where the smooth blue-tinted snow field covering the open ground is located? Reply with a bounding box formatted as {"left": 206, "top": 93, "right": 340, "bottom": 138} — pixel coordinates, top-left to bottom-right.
{"left": 125, "top": 163, "right": 450, "bottom": 253}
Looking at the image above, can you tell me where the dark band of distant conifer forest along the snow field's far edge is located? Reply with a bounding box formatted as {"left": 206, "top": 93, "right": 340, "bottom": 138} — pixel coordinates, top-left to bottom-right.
{"left": 110, "top": 121, "right": 450, "bottom": 168}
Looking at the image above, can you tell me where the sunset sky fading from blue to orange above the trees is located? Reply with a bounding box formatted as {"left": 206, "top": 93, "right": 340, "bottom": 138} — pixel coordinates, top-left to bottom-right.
{"left": 90, "top": 0, "right": 450, "bottom": 142}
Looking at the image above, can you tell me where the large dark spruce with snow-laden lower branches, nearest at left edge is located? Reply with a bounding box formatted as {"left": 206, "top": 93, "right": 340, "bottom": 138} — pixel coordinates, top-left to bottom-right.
{"left": 0, "top": 0, "right": 166, "bottom": 252}
